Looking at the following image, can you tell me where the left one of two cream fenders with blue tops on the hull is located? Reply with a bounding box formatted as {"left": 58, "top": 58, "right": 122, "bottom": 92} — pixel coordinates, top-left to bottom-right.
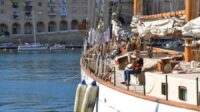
{"left": 74, "top": 80, "right": 87, "bottom": 112}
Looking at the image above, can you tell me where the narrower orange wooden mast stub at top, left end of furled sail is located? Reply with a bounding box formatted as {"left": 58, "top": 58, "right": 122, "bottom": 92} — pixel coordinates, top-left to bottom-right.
{"left": 133, "top": 0, "right": 143, "bottom": 16}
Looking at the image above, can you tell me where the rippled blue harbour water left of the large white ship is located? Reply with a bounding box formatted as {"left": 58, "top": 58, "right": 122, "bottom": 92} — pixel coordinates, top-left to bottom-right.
{"left": 0, "top": 49, "right": 81, "bottom": 112}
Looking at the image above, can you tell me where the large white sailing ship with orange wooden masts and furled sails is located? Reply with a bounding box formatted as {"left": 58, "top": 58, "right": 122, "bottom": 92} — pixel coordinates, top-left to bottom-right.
{"left": 74, "top": 0, "right": 200, "bottom": 112}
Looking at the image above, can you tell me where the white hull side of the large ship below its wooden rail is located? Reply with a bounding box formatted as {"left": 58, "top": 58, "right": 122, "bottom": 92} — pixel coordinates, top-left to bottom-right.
{"left": 81, "top": 68, "right": 198, "bottom": 112}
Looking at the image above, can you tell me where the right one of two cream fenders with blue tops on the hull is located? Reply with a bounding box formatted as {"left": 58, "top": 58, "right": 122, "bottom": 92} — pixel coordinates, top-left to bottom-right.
{"left": 81, "top": 81, "right": 98, "bottom": 112}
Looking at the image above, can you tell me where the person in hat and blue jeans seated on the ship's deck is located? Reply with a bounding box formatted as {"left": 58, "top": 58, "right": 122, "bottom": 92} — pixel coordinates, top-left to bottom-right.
{"left": 121, "top": 51, "right": 143, "bottom": 86}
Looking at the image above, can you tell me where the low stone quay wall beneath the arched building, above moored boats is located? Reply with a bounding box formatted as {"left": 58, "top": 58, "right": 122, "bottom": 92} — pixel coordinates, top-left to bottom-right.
{"left": 0, "top": 31, "right": 87, "bottom": 44}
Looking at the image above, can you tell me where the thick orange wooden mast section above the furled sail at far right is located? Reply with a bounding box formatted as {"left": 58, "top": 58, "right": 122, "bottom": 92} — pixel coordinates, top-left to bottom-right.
{"left": 185, "top": 0, "right": 199, "bottom": 22}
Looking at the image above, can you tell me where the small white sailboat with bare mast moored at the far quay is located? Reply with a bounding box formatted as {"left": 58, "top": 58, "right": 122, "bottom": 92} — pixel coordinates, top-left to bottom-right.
{"left": 18, "top": 9, "right": 48, "bottom": 51}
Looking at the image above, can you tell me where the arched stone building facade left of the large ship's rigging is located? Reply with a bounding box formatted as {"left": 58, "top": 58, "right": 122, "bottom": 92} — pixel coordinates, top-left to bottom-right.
{"left": 0, "top": 0, "right": 88, "bottom": 36}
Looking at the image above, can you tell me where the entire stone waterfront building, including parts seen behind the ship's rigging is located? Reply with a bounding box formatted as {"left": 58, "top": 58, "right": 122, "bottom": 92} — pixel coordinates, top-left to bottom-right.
{"left": 0, "top": 0, "right": 192, "bottom": 37}
